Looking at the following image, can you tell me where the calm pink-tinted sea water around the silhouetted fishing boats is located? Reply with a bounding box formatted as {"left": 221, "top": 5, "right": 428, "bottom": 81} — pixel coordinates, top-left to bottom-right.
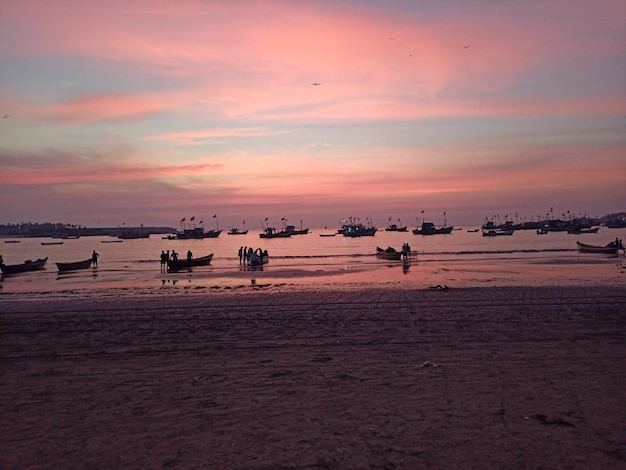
{"left": 0, "top": 227, "right": 626, "bottom": 295}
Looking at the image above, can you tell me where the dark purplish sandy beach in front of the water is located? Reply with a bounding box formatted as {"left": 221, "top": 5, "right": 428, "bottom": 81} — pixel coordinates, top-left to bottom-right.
{"left": 0, "top": 286, "right": 626, "bottom": 469}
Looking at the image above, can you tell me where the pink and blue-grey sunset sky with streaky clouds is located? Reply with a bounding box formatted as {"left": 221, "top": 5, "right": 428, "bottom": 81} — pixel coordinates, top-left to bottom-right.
{"left": 0, "top": 0, "right": 626, "bottom": 227}
